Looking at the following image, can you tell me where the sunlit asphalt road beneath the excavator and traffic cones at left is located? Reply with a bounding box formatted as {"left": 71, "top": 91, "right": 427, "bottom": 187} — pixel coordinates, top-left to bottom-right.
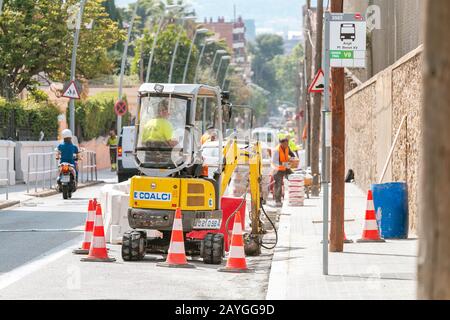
{"left": 0, "top": 182, "right": 272, "bottom": 300}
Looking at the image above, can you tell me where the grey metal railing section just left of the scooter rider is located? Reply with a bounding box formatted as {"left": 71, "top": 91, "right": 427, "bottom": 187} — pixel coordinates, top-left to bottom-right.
{"left": 27, "top": 152, "right": 58, "bottom": 193}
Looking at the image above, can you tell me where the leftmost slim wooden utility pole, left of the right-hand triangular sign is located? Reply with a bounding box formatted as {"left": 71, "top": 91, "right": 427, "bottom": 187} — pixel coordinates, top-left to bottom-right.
{"left": 304, "top": 0, "right": 312, "bottom": 166}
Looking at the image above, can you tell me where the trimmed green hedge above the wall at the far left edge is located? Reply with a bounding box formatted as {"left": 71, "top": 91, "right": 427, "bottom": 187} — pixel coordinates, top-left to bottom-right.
{"left": 0, "top": 92, "right": 60, "bottom": 140}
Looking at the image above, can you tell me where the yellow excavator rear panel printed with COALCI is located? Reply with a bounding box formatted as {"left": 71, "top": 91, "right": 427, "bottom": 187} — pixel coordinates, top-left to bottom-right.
{"left": 130, "top": 176, "right": 181, "bottom": 210}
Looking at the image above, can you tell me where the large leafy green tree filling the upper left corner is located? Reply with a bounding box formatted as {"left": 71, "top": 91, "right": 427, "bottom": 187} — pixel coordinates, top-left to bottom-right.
{"left": 0, "top": 0, "right": 123, "bottom": 98}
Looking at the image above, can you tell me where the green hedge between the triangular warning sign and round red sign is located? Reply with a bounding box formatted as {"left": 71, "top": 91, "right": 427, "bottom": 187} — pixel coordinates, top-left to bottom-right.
{"left": 67, "top": 92, "right": 130, "bottom": 141}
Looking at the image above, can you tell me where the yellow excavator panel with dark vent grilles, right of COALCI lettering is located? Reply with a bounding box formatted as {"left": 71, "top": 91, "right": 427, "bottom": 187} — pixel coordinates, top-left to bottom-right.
{"left": 180, "top": 179, "right": 216, "bottom": 211}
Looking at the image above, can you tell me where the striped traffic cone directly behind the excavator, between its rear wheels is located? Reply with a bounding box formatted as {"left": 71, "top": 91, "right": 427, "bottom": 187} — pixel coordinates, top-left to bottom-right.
{"left": 156, "top": 208, "right": 195, "bottom": 268}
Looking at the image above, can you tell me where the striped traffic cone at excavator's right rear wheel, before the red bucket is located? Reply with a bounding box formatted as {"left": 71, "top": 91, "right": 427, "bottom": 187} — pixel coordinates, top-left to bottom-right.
{"left": 218, "top": 211, "right": 254, "bottom": 273}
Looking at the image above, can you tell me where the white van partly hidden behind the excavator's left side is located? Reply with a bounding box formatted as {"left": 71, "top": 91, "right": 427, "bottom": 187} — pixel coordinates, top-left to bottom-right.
{"left": 117, "top": 127, "right": 139, "bottom": 182}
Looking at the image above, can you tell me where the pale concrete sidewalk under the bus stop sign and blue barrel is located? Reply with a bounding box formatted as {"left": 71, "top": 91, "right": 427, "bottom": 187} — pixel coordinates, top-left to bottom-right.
{"left": 267, "top": 184, "right": 418, "bottom": 300}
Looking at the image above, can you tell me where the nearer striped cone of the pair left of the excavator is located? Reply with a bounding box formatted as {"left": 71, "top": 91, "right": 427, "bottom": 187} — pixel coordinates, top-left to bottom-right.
{"left": 81, "top": 204, "right": 116, "bottom": 262}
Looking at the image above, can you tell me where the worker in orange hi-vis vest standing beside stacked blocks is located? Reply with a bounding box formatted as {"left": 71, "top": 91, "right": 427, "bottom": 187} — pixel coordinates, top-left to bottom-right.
{"left": 272, "top": 138, "right": 295, "bottom": 208}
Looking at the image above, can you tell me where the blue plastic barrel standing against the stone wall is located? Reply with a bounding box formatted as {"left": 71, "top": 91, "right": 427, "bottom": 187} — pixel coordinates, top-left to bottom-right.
{"left": 372, "top": 182, "right": 409, "bottom": 239}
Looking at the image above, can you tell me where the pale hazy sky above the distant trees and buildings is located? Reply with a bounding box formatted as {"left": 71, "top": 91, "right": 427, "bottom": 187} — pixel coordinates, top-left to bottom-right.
{"left": 116, "top": 0, "right": 305, "bottom": 33}
